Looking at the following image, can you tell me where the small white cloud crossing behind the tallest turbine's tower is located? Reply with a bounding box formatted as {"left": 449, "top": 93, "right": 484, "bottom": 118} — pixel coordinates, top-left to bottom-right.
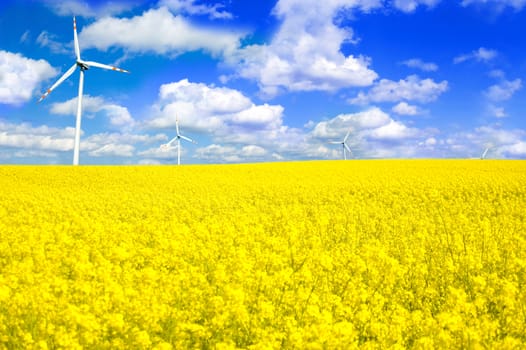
{"left": 51, "top": 95, "right": 135, "bottom": 128}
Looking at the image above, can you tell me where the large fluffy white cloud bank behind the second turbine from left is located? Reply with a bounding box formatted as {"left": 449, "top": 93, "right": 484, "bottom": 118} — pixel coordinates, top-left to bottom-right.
{"left": 145, "top": 79, "right": 318, "bottom": 162}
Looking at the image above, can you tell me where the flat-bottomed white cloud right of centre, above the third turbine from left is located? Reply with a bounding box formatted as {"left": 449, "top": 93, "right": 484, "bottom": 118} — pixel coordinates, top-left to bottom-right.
{"left": 349, "top": 75, "right": 448, "bottom": 104}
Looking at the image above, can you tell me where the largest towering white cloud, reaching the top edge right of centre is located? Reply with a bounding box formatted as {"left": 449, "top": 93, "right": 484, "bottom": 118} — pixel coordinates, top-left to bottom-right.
{"left": 228, "top": 0, "right": 378, "bottom": 96}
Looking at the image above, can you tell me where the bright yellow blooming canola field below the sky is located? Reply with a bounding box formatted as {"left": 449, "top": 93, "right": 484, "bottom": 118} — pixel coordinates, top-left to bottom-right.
{"left": 0, "top": 160, "right": 526, "bottom": 349}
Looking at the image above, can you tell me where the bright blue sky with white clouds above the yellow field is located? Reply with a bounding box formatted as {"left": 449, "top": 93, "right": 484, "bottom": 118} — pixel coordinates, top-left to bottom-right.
{"left": 0, "top": 0, "right": 526, "bottom": 164}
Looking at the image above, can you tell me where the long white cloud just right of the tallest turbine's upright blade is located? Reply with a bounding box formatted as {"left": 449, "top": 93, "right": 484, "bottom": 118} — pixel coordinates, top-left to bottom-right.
{"left": 79, "top": 7, "right": 245, "bottom": 56}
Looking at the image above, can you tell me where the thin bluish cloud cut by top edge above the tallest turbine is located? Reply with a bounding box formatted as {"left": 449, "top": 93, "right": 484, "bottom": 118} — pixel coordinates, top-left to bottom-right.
{"left": 44, "top": 0, "right": 139, "bottom": 17}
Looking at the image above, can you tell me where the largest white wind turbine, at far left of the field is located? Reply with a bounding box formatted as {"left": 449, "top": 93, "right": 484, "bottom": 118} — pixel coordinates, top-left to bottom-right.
{"left": 38, "top": 17, "right": 129, "bottom": 165}
